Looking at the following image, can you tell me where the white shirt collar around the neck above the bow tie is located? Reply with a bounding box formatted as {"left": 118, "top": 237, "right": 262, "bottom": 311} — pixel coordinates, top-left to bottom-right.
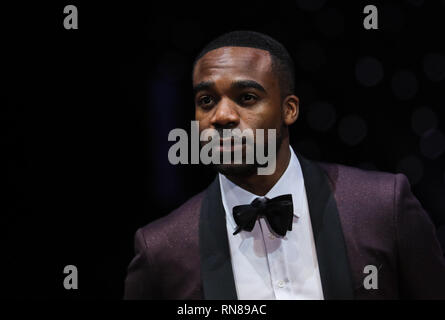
{"left": 219, "top": 146, "right": 304, "bottom": 229}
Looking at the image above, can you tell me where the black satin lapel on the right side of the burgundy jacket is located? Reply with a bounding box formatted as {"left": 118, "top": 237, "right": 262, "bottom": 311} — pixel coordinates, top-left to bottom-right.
{"left": 298, "top": 155, "right": 354, "bottom": 299}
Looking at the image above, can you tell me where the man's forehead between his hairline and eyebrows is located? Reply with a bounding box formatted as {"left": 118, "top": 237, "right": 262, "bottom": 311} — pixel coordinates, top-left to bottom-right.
{"left": 193, "top": 47, "right": 275, "bottom": 84}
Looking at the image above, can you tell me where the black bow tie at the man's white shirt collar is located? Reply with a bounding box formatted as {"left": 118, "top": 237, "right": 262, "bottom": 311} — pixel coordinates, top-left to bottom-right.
{"left": 233, "top": 194, "right": 294, "bottom": 237}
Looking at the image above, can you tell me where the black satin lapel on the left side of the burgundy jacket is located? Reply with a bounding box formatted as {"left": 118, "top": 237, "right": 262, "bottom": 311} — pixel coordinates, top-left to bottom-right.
{"left": 199, "top": 177, "right": 238, "bottom": 300}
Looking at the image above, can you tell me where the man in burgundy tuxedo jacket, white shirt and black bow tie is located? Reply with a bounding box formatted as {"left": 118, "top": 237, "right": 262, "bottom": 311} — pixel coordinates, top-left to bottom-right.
{"left": 125, "top": 31, "right": 445, "bottom": 299}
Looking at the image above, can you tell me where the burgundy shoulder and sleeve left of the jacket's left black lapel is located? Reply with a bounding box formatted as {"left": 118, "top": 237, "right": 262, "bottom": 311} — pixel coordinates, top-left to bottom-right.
{"left": 125, "top": 191, "right": 205, "bottom": 299}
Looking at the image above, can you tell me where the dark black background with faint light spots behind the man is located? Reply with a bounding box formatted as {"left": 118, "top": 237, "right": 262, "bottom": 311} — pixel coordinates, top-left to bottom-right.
{"left": 0, "top": 0, "right": 445, "bottom": 299}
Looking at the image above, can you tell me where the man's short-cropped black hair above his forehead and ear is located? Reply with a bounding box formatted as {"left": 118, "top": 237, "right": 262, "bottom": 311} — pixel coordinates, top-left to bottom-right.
{"left": 192, "top": 30, "right": 295, "bottom": 97}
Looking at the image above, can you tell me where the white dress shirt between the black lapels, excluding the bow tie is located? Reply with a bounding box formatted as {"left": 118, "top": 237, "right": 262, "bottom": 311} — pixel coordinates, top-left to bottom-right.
{"left": 219, "top": 148, "right": 323, "bottom": 300}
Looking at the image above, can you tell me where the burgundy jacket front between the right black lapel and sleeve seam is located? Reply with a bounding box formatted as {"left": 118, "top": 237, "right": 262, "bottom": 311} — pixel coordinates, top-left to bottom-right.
{"left": 314, "top": 163, "right": 407, "bottom": 299}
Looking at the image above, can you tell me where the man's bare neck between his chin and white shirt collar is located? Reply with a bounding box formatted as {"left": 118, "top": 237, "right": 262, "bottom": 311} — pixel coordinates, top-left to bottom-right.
{"left": 222, "top": 137, "right": 291, "bottom": 196}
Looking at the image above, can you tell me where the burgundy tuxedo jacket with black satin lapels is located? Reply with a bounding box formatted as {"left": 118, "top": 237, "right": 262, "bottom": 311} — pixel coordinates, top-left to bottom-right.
{"left": 124, "top": 155, "right": 445, "bottom": 300}
